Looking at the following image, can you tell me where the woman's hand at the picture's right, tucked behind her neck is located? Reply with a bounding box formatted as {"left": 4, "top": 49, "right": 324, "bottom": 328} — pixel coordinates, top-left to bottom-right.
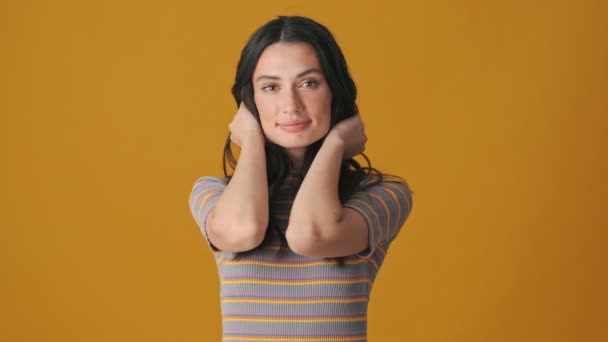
{"left": 326, "top": 113, "right": 367, "bottom": 159}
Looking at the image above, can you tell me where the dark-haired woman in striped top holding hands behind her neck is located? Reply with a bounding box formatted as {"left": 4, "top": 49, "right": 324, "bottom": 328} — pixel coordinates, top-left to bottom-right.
{"left": 190, "top": 17, "right": 412, "bottom": 341}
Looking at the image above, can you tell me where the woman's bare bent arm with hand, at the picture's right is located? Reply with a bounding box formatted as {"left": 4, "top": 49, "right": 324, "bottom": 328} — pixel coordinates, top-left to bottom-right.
{"left": 286, "top": 114, "right": 368, "bottom": 257}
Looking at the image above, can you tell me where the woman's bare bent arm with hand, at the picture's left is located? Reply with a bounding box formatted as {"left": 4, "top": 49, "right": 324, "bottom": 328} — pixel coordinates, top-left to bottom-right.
{"left": 205, "top": 104, "right": 268, "bottom": 252}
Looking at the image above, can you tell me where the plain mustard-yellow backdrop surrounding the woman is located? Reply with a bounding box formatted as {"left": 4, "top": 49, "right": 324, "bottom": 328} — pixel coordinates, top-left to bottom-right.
{"left": 0, "top": 0, "right": 608, "bottom": 342}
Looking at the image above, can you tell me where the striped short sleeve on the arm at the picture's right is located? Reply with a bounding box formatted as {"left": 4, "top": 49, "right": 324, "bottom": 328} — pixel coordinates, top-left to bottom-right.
{"left": 343, "top": 176, "right": 412, "bottom": 258}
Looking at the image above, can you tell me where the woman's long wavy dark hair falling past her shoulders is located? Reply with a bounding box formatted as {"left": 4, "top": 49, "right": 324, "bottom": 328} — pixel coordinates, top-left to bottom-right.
{"left": 223, "top": 16, "right": 382, "bottom": 253}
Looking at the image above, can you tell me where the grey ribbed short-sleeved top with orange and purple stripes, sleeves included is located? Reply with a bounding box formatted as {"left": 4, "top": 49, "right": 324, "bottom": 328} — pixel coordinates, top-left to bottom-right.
{"left": 189, "top": 176, "right": 412, "bottom": 342}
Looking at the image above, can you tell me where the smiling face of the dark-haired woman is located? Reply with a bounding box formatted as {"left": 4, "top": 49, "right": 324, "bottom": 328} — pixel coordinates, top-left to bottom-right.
{"left": 252, "top": 42, "right": 332, "bottom": 161}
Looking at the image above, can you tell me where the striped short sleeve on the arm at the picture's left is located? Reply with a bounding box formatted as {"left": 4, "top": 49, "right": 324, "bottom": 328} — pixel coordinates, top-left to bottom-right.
{"left": 189, "top": 176, "right": 226, "bottom": 251}
